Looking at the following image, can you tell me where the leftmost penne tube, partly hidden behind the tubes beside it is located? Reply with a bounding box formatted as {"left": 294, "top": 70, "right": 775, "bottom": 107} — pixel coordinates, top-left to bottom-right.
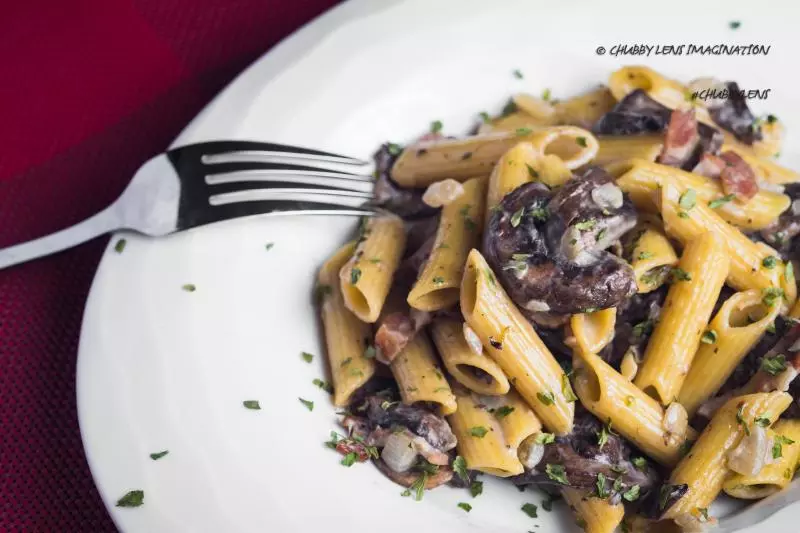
{"left": 317, "top": 242, "right": 375, "bottom": 407}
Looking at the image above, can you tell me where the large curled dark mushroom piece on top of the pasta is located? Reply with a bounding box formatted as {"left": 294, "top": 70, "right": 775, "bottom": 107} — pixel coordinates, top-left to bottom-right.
{"left": 483, "top": 168, "right": 636, "bottom": 321}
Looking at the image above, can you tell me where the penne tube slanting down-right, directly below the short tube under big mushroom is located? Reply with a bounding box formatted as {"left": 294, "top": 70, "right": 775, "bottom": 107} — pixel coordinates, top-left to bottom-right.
{"left": 575, "top": 350, "right": 695, "bottom": 466}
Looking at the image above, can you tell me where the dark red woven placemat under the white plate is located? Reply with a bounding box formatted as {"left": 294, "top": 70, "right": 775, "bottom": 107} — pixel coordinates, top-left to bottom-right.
{"left": 0, "top": 0, "right": 338, "bottom": 532}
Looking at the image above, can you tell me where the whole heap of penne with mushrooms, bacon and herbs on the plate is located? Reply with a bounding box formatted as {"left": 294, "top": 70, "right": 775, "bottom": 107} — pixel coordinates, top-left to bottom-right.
{"left": 310, "top": 67, "right": 800, "bottom": 533}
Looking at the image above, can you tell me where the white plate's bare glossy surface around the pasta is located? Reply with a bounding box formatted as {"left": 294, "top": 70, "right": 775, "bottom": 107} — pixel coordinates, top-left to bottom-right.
{"left": 77, "top": 0, "right": 800, "bottom": 533}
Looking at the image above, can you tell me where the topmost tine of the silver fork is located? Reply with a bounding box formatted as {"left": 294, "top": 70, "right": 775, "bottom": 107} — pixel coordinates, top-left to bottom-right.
{"left": 176, "top": 141, "right": 369, "bottom": 166}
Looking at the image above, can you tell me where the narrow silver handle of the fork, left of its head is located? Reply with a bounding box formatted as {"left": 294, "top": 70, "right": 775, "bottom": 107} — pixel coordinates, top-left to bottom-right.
{"left": 0, "top": 205, "right": 121, "bottom": 270}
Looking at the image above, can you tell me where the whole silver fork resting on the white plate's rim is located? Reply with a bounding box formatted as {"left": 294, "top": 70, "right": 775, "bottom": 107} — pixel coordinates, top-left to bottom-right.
{"left": 0, "top": 141, "right": 376, "bottom": 269}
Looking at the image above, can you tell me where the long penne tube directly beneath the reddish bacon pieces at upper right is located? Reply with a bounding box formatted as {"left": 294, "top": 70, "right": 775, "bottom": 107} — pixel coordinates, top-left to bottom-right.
{"left": 615, "top": 159, "right": 792, "bottom": 230}
